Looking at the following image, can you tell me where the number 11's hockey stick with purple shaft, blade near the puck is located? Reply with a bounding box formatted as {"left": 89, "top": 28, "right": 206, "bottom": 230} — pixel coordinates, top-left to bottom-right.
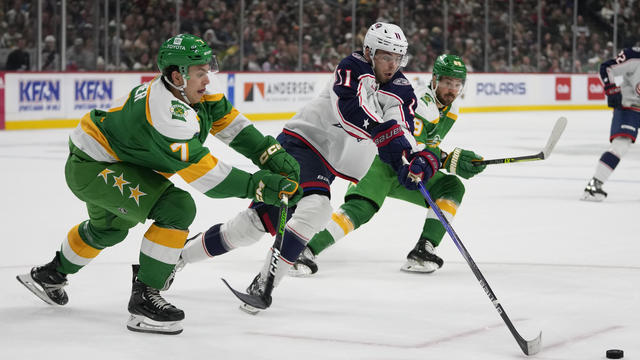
{"left": 402, "top": 157, "right": 542, "bottom": 355}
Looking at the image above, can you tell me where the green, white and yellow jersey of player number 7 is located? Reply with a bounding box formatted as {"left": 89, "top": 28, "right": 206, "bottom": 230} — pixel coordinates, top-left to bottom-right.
{"left": 70, "top": 77, "right": 264, "bottom": 197}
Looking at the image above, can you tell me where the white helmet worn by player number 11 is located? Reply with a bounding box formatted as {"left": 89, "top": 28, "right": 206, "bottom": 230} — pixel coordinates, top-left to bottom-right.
{"left": 364, "top": 22, "right": 409, "bottom": 67}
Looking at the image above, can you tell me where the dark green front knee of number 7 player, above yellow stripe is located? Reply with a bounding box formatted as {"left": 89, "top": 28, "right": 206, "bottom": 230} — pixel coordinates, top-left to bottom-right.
{"left": 149, "top": 186, "right": 196, "bottom": 230}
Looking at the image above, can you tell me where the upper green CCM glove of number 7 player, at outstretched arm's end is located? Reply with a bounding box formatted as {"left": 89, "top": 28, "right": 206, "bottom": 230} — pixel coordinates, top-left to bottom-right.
{"left": 251, "top": 136, "right": 300, "bottom": 182}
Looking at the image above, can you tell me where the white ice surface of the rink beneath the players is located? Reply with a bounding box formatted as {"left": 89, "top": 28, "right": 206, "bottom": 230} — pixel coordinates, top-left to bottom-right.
{"left": 0, "top": 111, "right": 640, "bottom": 360}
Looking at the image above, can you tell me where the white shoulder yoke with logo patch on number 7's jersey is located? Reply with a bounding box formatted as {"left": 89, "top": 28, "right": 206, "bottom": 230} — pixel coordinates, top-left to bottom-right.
{"left": 147, "top": 78, "right": 200, "bottom": 140}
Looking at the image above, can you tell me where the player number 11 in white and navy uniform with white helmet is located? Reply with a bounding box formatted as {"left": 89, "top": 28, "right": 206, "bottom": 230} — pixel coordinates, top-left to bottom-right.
{"left": 182, "top": 22, "right": 440, "bottom": 310}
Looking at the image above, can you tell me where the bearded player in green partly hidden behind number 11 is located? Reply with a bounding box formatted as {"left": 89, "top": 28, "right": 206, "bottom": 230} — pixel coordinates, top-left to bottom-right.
{"left": 289, "top": 55, "right": 486, "bottom": 276}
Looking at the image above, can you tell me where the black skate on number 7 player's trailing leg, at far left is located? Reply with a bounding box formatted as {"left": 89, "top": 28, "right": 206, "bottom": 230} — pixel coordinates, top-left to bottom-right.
{"left": 16, "top": 251, "right": 69, "bottom": 305}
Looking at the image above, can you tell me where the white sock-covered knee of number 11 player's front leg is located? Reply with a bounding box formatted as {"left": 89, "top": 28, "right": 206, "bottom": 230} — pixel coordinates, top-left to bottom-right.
{"left": 287, "top": 194, "right": 333, "bottom": 241}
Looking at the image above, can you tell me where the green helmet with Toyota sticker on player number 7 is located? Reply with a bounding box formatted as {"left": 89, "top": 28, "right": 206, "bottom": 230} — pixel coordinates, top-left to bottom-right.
{"left": 158, "top": 34, "right": 218, "bottom": 79}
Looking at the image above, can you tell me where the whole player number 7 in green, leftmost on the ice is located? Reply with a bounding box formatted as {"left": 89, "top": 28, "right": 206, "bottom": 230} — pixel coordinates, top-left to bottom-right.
{"left": 17, "top": 34, "right": 301, "bottom": 334}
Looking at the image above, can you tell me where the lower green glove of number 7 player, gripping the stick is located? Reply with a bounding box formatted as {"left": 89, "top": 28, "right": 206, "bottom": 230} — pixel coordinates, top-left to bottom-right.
{"left": 247, "top": 170, "right": 302, "bottom": 206}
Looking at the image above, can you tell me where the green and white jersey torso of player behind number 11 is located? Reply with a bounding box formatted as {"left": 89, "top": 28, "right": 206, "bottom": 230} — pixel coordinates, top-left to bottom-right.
{"left": 413, "top": 85, "right": 459, "bottom": 156}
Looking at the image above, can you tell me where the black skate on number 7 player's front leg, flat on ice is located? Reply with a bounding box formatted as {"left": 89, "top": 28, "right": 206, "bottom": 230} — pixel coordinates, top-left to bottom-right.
{"left": 127, "top": 265, "right": 184, "bottom": 335}
